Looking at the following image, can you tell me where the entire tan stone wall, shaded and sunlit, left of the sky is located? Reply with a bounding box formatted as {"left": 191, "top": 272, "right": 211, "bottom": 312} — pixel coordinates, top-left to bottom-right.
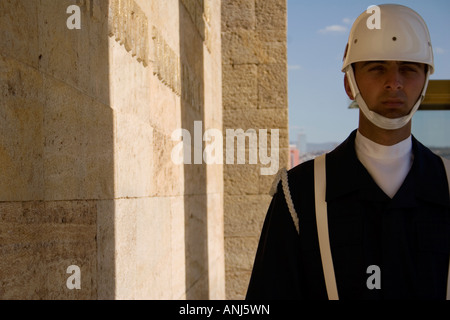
{"left": 0, "top": 0, "right": 288, "bottom": 299}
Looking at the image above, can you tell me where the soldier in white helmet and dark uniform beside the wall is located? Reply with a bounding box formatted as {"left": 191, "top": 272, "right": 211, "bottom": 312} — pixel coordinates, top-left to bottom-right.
{"left": 247, "top": 5, "right": 450, "bottom": 299}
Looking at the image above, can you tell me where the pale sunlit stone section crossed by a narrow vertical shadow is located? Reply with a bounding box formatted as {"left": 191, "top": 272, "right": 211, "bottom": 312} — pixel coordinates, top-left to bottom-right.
{"left": 94, "top": 0, "right": 225, "bottom": 299}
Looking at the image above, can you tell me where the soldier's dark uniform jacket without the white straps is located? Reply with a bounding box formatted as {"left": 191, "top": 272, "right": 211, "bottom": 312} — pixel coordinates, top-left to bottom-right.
{"left": 247, "top": 131, "right": 450, "bottom": 299}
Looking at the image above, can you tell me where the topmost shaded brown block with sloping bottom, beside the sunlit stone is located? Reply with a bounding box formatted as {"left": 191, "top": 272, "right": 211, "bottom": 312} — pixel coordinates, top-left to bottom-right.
{"left": 37, "top": 0, "right": 109, "bottom": 103}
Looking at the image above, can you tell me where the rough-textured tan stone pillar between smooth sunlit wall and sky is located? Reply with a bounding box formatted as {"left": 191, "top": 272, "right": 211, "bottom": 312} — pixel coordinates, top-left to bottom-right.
{"left": 222, "top": 0, "right": 289, "bottom": 299}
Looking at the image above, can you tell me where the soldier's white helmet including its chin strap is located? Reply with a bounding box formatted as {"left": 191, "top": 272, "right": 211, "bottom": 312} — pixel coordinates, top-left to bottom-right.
{"left": 342, "top": 4, "right": 434, "bottom": 130}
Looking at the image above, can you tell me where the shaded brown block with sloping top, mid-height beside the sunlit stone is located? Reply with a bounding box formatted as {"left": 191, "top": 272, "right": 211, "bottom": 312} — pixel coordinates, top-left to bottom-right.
{"left": 43, "top": 77, "right": 114, "bottom": 200}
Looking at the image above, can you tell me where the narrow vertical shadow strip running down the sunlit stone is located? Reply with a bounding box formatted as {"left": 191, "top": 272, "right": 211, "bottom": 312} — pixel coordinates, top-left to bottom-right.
{"left": 178, "top": 1, "right": 209, "bottom": 300}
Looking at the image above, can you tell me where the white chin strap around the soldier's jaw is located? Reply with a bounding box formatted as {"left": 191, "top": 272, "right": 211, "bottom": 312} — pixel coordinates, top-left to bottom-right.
{"left": 346, "top": 66, "right": 430, "bottom": 130}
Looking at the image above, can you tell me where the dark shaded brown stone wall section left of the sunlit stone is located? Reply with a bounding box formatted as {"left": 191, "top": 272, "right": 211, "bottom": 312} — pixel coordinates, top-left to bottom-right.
{"left": 0, "top": 0, "right": 114, "bottom": 299}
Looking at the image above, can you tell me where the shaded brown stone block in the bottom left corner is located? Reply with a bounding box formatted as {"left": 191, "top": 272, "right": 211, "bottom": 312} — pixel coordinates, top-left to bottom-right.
{"left": 0, "top": 201, "right": 97, "bottom": 300}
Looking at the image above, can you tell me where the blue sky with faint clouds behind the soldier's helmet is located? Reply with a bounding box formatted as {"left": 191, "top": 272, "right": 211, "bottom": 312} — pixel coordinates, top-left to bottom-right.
{"left": 288, "top": 0, "right": 450, "bottom": 143}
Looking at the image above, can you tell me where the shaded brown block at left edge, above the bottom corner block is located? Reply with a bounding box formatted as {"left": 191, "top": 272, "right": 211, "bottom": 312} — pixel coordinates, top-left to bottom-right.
{"left": 0, "top": 55, "right": 44, "bottom": 201}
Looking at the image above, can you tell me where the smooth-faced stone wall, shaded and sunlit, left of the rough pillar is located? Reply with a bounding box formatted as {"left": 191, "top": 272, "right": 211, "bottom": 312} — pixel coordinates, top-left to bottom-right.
{"left": 0, "top": 0, "right": 225, "bottom": 299}
